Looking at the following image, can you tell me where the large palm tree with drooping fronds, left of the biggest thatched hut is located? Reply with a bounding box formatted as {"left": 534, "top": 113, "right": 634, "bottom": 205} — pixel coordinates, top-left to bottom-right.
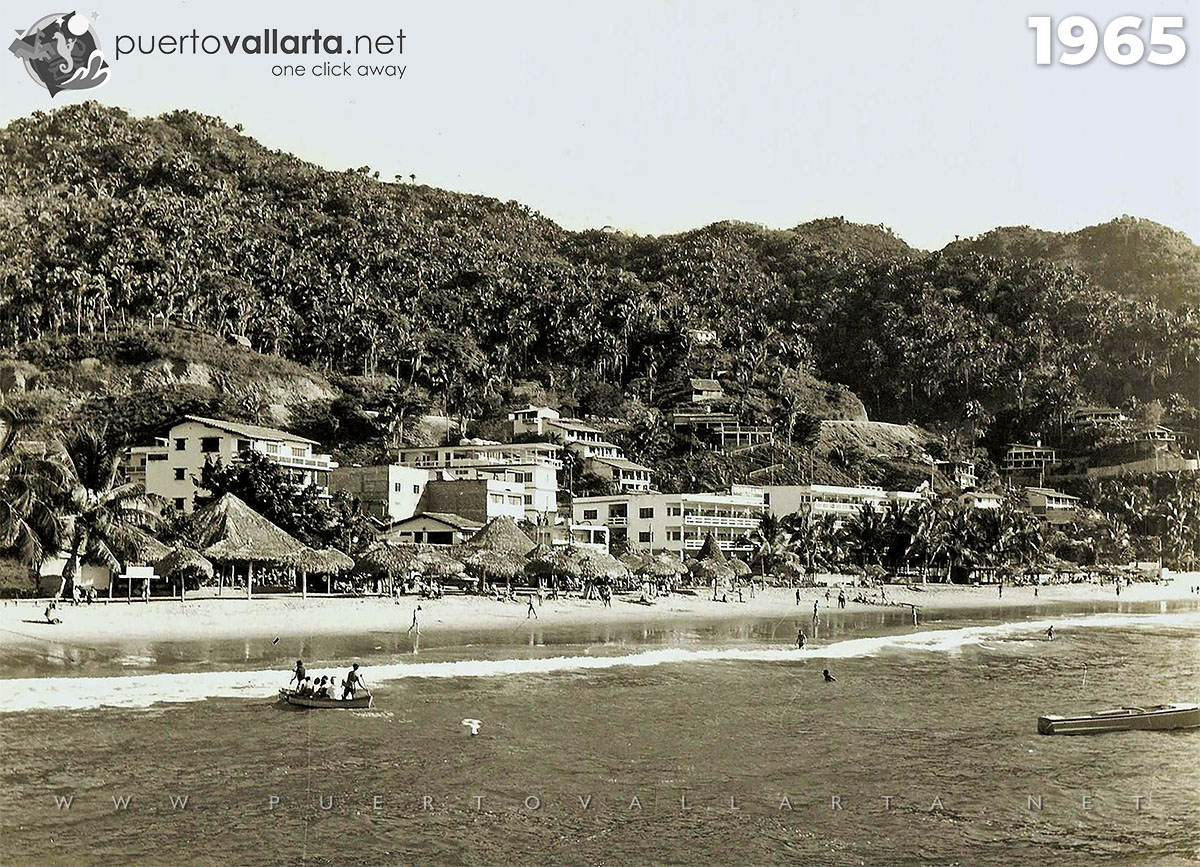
{"left": 54, "top": 431, "right": 161, "bottom": 597}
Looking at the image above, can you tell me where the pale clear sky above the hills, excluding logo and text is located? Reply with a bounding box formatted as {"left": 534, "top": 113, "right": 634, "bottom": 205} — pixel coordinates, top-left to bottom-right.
{"left": 0, "top": 0, "right": 1200, "bottom": 249}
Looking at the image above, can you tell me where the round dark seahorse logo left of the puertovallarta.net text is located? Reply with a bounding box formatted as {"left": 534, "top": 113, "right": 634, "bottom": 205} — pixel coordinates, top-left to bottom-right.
{"left": 8, "top": 12, "right": 108, "bottom": 96}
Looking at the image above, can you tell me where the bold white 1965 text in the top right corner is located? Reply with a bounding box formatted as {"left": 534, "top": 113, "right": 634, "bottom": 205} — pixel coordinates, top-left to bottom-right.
{"left": 1028, "top": 16, "right": 1188, "bottom": 66}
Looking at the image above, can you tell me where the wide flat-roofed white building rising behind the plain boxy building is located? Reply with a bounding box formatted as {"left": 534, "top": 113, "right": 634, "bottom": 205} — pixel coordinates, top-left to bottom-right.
{"left": 397, "top": 440, "right": 563, "bottom": 520}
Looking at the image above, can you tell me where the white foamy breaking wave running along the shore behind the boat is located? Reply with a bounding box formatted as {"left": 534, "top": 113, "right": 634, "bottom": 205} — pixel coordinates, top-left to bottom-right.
{"left": 0, "top": 611, "right": 1200, "bottom": 712}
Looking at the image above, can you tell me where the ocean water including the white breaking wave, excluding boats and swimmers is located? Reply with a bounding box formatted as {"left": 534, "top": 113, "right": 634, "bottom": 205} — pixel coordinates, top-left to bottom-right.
{"left": 0, "top": 605, "right": 1200, "bottom": 865}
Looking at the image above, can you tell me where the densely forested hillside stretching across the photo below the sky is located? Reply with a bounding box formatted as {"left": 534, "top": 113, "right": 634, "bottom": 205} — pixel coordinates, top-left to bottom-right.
{"left": 0, "top": 103, "right": 1200, "bottom": 458}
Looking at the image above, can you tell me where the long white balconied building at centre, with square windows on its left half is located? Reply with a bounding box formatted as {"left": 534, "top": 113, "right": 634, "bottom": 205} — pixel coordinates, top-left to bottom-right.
{"left": 571, "top": 485, "right": 767, "bottom": 558}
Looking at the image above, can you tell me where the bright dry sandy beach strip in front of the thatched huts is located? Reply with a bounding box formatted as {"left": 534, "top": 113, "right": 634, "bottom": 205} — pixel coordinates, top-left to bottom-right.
{"left": 0, "top": 573, "right": 1200, "bottom": 647}
